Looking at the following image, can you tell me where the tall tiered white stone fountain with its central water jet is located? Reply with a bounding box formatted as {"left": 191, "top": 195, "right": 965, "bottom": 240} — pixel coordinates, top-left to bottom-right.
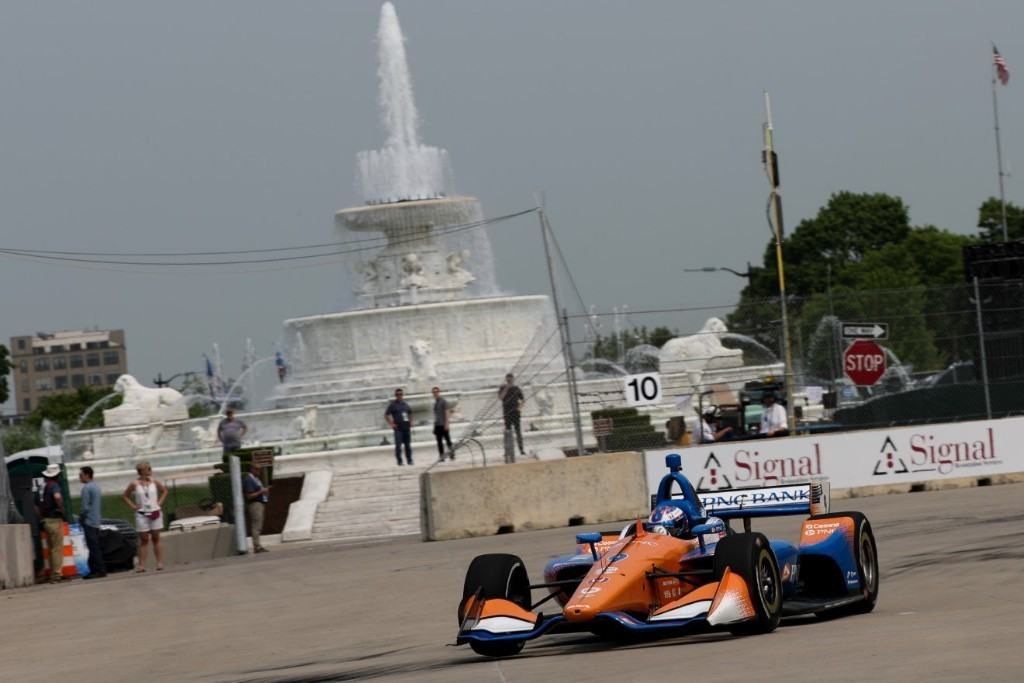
{"left": 272, "top": 2, "right": 554, "bottom": 411}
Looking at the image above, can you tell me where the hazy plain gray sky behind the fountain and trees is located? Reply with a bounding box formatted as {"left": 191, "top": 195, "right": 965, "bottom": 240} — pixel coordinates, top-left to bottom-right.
{"left": 0, "top": 0, "right": 1024, "bottom": 411}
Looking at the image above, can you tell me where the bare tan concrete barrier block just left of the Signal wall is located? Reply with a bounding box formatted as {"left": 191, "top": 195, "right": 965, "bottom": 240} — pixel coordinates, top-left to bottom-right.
{"left": 420, "top": 453, "right": 649, "bottom": 541}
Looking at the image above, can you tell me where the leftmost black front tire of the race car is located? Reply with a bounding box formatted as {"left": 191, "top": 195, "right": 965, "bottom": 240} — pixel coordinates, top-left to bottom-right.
{"left": 459, "top": 553, "right": 531, "bottom": 657}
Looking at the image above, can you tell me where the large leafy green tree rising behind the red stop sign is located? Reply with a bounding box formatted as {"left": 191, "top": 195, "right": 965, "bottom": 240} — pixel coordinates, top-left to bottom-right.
{"left": 728, "top": 193, "right": 971, "bottom": 378}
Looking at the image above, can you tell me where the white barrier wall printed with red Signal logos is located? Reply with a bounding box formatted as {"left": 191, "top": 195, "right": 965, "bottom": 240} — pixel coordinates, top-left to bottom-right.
{"left": 644, "top": 418, "right": 1024, "bottom": 494}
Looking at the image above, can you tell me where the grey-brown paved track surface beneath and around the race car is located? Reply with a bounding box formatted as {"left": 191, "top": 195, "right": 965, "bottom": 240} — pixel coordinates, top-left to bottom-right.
{"left": 0, "top": 484, "right": 1024, "bottom": 683}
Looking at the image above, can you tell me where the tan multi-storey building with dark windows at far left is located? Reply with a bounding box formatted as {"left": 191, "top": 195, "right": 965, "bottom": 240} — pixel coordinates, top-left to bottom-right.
{"left": 10, "top": 330, "right": 128, "bottom": 413}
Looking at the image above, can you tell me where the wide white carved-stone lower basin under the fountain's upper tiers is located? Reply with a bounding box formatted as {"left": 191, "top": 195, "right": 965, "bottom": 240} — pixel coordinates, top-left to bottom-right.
{"left": 273, "top": 296, "right": 558, "bottom": 410}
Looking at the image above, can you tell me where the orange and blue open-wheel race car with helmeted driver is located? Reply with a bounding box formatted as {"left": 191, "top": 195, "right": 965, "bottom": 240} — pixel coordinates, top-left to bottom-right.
{"left": 456, "top": 454, "right": 879, "bottom": 657}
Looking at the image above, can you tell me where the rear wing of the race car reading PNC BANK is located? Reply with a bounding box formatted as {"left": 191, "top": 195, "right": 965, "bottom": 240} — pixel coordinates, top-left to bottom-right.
{"left": 697, "top": 479, "right": 830, "bottom": 519}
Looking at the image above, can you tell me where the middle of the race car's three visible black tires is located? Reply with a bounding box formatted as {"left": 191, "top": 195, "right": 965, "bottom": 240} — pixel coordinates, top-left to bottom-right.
{"left": 715, "top": 532, "right": 782, "bottom": 636}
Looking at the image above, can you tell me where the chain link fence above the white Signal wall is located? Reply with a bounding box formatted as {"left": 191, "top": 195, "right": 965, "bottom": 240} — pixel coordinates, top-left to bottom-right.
{"left": 568, "top": 281, "right": 1024, "bottom": 450}
